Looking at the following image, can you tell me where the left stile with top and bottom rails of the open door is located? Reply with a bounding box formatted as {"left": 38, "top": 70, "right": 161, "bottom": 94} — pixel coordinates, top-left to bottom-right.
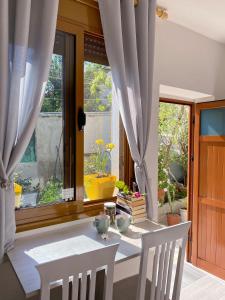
{"left": 191, "top": 100, "right": 225, "bottom": 270}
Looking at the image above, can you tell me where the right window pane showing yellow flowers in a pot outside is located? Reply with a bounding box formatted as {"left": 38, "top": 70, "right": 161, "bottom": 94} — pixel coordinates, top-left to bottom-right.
{"left": 84, "top": 61, "right": 119, "bottom": 200}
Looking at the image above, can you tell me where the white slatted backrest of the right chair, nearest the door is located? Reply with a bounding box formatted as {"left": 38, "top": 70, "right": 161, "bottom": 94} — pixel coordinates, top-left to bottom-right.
{"left": 136, "top": 222, "right": 191, "bottom": 300}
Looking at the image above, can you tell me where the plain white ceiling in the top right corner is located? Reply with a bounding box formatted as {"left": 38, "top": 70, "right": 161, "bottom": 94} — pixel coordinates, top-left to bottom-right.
{"left": 157, "top": 0, "right": 225, "bottom": 43}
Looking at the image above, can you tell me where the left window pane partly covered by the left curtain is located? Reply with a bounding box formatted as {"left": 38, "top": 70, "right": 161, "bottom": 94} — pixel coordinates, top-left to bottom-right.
{"left": 15, "top": 54, "right": 64, "bottom": 207}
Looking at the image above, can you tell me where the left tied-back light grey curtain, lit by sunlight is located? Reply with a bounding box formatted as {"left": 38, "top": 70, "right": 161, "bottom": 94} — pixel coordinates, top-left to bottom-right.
{"left": 0, "top": 0, "right": 58, "bottom": 260}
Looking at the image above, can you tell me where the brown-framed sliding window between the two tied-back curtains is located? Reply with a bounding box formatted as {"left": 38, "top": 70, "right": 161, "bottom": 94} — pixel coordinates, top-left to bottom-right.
{"left": 15, "top": 22, "right": 133, "bottom": 231}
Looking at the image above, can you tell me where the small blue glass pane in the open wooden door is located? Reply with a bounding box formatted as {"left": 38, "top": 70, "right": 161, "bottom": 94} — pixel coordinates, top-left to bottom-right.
{"left": 200, "top": 108, "right": 225, "bottom": 136}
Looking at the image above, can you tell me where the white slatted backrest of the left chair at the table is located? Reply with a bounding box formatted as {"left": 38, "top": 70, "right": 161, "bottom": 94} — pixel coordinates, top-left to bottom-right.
{"left": 36, "top": 244, "right": 118, "bottom": 300}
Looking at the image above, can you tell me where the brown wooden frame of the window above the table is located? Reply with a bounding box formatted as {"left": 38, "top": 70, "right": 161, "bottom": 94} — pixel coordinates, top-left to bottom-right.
{"left": 16, "top": 17, "right": 134, "bottom": 232}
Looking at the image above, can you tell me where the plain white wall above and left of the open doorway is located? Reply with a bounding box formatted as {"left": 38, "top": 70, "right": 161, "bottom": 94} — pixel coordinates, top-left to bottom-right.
{"left": 146, "top": 18, "right": 225, "bottom": 220}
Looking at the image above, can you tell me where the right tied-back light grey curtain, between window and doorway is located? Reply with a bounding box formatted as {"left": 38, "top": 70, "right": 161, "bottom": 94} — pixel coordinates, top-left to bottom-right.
{"left": 99, "top": 0, "right": 158, "bottom": 220}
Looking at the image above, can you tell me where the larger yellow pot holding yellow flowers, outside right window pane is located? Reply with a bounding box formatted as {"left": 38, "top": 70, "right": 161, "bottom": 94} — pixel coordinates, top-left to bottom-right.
{"left": 84, "top": 174, "right": 116, "bottom": 200}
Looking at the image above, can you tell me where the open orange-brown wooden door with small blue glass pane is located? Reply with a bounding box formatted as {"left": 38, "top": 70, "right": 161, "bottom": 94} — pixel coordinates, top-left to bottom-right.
{"left": 192, "top": 101, "right": 225, "bottom": 279}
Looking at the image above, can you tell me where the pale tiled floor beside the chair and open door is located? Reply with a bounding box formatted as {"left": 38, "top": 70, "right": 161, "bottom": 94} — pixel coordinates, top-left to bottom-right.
{"left": 180, "top": 263, "right": 225, "bottom": 300}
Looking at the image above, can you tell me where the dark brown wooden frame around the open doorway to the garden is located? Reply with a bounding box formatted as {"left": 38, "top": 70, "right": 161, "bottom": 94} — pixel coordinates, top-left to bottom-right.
{"left": 159, "top": 97, "right": 195, "bottom": 262}
